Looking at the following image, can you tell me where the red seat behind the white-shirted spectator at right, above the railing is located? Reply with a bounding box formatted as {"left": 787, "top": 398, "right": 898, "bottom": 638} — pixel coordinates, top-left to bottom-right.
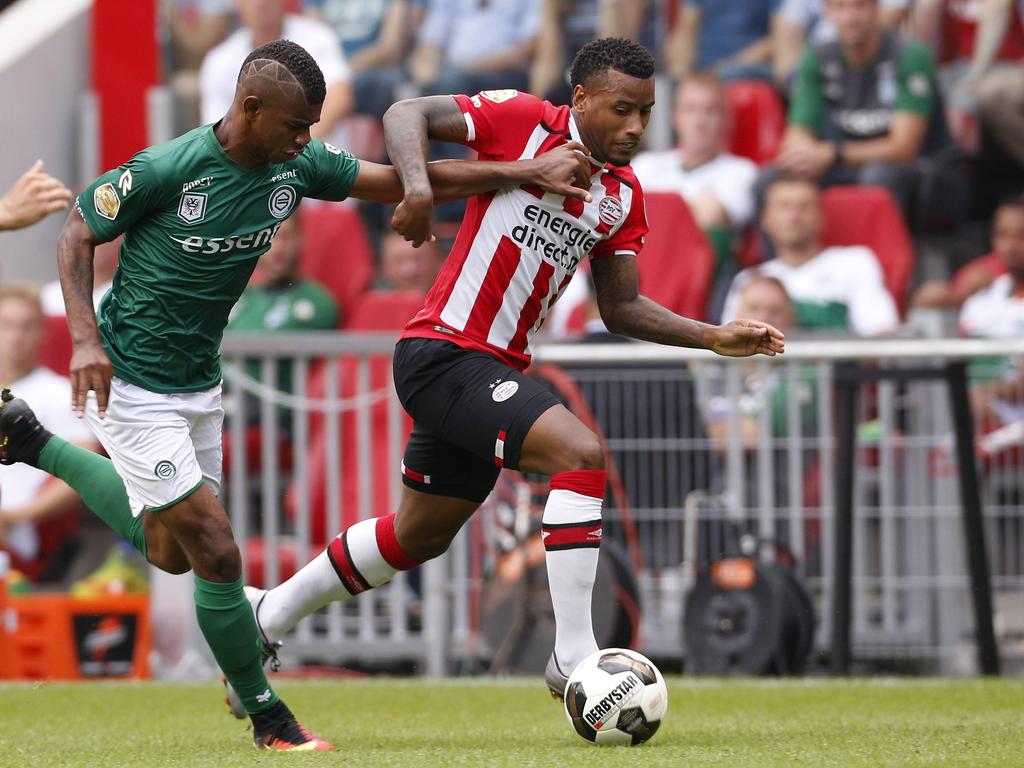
{"left": 821, "top": 186, "right": 914, "bottom": 313}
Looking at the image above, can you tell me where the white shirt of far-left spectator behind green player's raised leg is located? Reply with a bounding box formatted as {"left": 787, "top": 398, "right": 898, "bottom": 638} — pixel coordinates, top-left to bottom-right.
{"left": 0, "top": 367, "right": 95, "bottom": 560}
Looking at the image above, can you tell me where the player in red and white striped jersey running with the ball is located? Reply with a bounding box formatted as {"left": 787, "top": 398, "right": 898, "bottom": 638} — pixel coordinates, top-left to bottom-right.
{"left": 248, "top": 38, "right": 783, "bottom": 696}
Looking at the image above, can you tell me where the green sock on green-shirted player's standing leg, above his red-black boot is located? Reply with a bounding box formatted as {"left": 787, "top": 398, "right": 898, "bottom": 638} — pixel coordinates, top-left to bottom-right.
{"left": 196, "top": 577, "right": 279, "bottom": 715}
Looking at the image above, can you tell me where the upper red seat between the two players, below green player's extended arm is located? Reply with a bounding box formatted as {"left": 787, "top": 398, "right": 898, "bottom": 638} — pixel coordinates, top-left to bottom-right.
{"left": 300, "top": 204, "right": 374, "bottom": 317}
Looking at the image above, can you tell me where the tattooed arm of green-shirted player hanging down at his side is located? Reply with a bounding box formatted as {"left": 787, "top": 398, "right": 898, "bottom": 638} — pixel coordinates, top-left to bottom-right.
{"left": 57, "top": 211, "right": 114, "bottom": 418}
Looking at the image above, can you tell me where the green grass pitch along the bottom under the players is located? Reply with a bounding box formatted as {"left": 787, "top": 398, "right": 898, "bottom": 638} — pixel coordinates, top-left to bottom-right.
{"left": 0, "top": 678, "right": 1024, "bottom": 768}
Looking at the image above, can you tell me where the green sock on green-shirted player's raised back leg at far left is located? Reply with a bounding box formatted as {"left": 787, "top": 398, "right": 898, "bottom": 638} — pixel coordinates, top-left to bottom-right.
{"left": 39, "top": 436, "right": 148, "bottom": 557}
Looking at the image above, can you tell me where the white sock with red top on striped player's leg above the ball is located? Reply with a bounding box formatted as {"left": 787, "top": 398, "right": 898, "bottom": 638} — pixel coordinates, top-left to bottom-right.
{"left": 541, "top": 469, "right": 605, "bottom": 675}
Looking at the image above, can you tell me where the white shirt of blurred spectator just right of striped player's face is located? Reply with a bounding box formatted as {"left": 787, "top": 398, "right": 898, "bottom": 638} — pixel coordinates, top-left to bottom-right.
{"left": 632, "top": 150, "right": 758, "bottom": 229}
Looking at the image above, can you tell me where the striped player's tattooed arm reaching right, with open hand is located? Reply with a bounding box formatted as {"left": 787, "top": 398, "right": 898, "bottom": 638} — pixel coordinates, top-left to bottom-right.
{"left": 591, "top": 254, "right": 785, "bottom": 357}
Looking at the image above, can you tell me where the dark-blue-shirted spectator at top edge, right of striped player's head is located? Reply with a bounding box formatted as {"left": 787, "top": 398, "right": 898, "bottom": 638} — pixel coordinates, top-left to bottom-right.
{"left": 666, "top": 0, "right": 779, "bottom": 80}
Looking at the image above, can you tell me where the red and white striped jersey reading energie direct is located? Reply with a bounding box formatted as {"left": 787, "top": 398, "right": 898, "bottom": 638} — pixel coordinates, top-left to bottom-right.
{"left": 402, "top": 90, "right": 647, "bottom": 371}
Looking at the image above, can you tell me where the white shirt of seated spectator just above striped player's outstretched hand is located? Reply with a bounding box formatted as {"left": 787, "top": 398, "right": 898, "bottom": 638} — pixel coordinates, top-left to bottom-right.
{"left": 722, "top": 246, "right": 899, "bottom": 336}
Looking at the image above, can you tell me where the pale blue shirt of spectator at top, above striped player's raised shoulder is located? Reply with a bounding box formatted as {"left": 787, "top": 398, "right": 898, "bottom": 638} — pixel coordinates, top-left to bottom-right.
{"left": 419, "top": 0, "right": 542, "bottom": 69}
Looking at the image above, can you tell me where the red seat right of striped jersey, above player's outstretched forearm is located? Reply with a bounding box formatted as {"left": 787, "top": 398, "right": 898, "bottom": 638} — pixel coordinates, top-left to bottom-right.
{"left": 637, "top": 193, "right": 715, "bottom": 319}
